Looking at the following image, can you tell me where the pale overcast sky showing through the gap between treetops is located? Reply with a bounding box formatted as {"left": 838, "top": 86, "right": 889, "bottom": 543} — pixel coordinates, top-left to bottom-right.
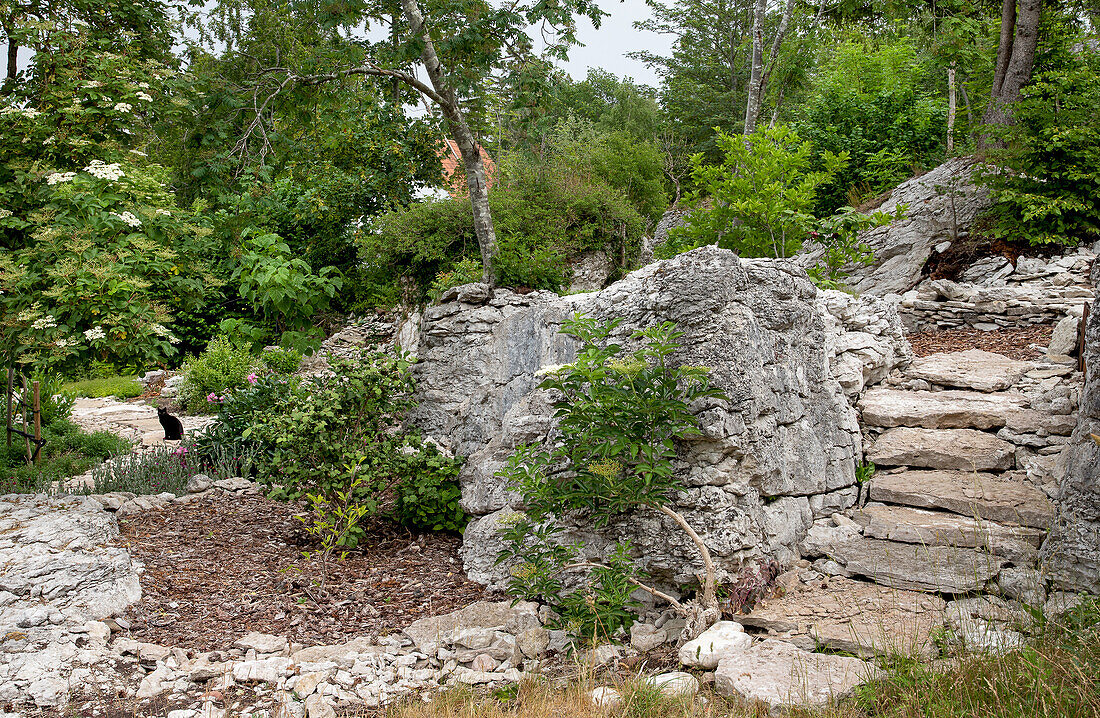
{"left": 0, "top": 0, "right": 671, "bottom": 87}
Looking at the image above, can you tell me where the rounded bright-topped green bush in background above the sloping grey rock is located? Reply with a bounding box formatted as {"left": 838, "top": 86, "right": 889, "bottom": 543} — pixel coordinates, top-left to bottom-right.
{"left": 796, "top": 37, "right": 947, "bottom": 213}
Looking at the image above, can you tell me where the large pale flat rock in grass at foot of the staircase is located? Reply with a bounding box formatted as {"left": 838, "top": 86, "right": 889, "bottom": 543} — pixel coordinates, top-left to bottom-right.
{"left": 714, "top": 639, "right": 878, "bottom": 709}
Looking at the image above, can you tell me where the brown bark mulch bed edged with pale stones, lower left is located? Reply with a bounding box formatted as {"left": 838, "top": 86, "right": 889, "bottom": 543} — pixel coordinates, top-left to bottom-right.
{"left": 119, "top": 495, "right": 502, "bottom": 651}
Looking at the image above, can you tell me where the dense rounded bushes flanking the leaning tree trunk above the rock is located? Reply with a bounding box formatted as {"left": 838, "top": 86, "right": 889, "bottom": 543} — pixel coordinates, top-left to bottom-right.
{"left": 359, "top": 121, "right": 651, "bottom": 300}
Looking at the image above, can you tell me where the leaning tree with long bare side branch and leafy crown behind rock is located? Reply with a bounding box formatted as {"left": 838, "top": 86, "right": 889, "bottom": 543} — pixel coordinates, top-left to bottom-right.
{"left": 192, "top": 0, "right": 605, "bottom": 284}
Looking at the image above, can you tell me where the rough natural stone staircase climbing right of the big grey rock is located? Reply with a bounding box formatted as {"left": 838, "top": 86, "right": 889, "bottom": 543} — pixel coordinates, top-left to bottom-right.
{"left": 739, "top": 350, "right": 1079, "bottom": 656}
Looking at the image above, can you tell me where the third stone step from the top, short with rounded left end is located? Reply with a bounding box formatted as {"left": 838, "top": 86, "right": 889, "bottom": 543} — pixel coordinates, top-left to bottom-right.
{"left": 867, "top": 427, "right": 1016, "bottom": 472}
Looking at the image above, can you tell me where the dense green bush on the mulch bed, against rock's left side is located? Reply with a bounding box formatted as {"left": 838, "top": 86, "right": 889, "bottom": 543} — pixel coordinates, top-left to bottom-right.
{"left": 196, "top": 352, "right": 466, "bottom": 536}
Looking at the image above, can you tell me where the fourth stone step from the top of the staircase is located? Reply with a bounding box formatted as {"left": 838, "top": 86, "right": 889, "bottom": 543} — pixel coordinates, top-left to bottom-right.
{"left": 870, "top": 471, "right": 1054, "bottom": 529}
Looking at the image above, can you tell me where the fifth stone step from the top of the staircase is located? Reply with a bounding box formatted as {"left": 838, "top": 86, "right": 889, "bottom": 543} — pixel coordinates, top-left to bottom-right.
{"left": 853, "top": 504, "right": 1046, "bottom": 566}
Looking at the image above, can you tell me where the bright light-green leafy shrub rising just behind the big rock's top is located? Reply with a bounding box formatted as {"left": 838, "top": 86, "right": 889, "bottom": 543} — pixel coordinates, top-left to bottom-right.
{"left": 661, "top": 125, "right": 848, "bottom": 257}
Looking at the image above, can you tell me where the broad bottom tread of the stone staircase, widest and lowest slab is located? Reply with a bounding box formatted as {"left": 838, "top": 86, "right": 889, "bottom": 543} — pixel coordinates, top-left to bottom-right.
{"left": 735, "top": 576, "right": 946, "bottom": 658}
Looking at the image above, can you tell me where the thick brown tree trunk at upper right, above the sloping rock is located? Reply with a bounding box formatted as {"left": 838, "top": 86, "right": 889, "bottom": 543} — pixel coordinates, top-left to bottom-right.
{"left": 979, "top": 0, "right": 1043, "bottom": 147}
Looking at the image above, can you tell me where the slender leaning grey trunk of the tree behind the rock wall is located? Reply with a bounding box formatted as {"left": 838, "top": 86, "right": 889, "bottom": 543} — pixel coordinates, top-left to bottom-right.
{"left": 402, "top": 0, "right": 496, "bottom": 286}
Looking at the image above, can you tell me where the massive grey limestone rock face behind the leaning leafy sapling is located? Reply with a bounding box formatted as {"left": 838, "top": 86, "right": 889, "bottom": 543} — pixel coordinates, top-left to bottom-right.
{"left": 415, "top": 247, "right": 908, "bottom": 583}
